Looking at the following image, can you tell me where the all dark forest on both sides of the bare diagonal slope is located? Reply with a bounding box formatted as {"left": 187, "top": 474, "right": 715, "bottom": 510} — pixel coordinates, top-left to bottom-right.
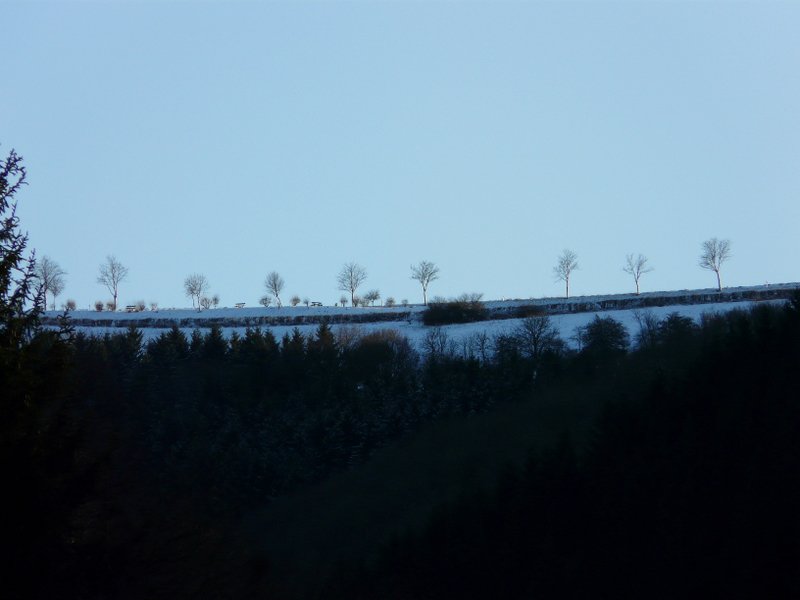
{"left": 3, "top": 299, "right": 800, "bottom": 598}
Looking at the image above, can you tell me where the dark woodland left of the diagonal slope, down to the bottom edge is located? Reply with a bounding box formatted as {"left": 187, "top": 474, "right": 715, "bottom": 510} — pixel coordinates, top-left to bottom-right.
{"left": 3, "top": 316, "right": 560, "bottom": 598}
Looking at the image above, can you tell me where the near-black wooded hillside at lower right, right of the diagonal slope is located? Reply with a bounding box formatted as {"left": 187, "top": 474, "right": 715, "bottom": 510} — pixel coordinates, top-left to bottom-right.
{"left": 322, "top": 296, "right": 800, "bottom": 599}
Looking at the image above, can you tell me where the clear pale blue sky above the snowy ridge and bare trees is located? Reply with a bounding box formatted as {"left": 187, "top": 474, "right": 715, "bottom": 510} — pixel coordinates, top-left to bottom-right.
{"left": 0, "top": 0, "right": 800, "bottom": 308}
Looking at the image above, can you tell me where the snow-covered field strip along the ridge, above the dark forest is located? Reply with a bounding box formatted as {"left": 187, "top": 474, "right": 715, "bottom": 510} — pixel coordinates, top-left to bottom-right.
{"left": 45, "top": 283, "right": 800, "bottom": 350}
